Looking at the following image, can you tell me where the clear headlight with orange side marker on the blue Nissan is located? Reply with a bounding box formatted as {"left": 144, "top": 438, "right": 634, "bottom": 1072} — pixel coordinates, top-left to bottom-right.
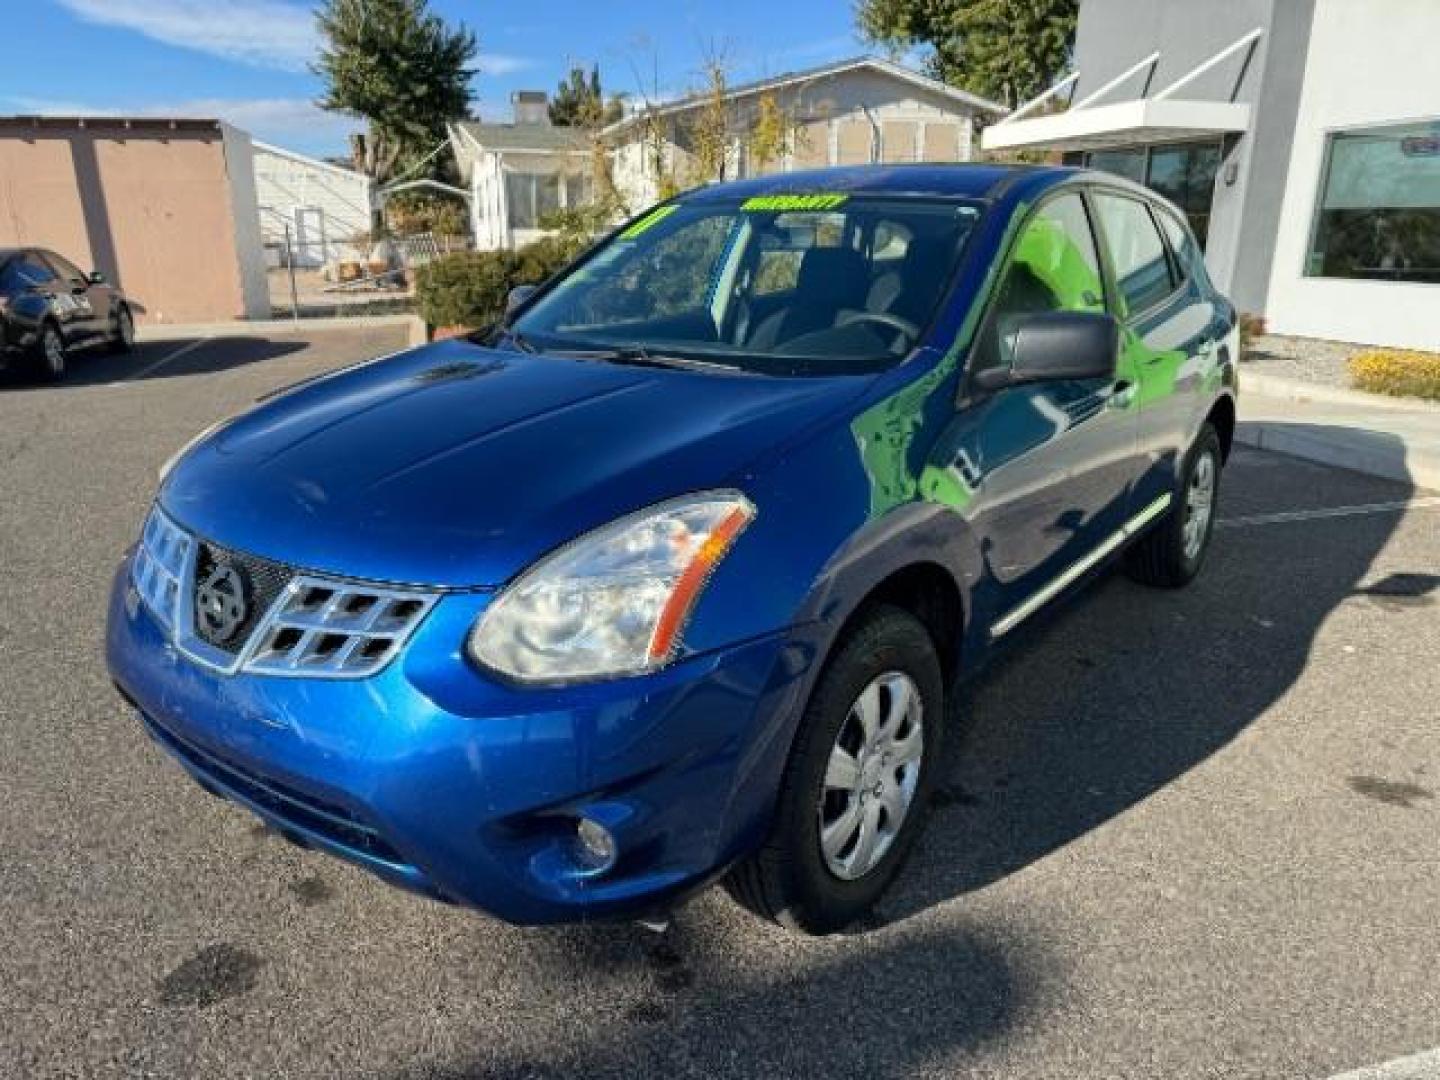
{"left": 469, "top": 491, "right": 755, "bottom": 683}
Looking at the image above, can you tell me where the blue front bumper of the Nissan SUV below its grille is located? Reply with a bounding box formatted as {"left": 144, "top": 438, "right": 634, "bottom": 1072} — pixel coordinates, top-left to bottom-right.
{"left": 107, "top": 557, "right": 814, "bottom": 923}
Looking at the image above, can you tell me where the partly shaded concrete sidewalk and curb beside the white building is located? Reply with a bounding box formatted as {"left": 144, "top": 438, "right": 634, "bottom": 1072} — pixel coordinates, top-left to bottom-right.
{"left": 1236, "top": 376, "right": 1440, "bottom": 491}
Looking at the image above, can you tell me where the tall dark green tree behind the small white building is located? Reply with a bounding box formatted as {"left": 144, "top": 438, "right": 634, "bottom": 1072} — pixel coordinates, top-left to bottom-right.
{"left": 314, "top": 0, "right": 478, "bottom": 192}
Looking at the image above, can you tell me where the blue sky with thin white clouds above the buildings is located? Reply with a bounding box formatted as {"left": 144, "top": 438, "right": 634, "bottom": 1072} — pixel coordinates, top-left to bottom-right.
{"left": 0, "top": 0, "right": 865, "bottom": 154}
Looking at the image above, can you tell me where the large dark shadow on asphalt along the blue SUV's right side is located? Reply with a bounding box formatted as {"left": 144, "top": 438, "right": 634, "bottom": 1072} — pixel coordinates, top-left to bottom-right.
{"left": 877, "top": 441, "right": 1416, "bottom": 922}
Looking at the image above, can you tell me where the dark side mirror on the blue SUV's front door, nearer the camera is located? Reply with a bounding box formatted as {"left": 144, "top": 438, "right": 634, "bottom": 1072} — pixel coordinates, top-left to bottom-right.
{"left": 975, "top": 311, "right": 1120, "bottom": 390}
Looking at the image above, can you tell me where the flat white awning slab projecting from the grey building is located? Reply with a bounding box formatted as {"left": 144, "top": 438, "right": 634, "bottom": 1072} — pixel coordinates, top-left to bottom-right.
{"left": 981, "top": 98, "right": 1250, "bottom": 150}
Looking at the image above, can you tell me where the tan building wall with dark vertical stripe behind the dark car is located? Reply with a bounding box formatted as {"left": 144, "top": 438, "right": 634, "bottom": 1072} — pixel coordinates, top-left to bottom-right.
{"left": 0, "top": 118, "right": 268, "bottom": 323}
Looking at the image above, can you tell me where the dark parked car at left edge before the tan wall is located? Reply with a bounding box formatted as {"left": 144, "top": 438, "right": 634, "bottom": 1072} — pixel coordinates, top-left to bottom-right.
{"left": 0, "top": 248, "right": 135, "bottom": 382}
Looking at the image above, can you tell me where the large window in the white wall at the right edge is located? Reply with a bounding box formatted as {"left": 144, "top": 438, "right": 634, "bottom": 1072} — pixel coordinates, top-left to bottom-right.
{"left": 1305, "top": 121, "right": 1440, "bottom": 284}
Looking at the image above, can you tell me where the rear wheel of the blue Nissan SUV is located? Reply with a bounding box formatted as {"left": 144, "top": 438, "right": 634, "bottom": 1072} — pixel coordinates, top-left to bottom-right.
{"left": 1126, "top": 423, "right": 1224, "bottom": 589}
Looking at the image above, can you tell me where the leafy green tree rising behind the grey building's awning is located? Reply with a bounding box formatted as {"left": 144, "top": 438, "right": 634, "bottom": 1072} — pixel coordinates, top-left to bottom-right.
{"left": 855, "top": 0, "right": 1080, "bottom": 107}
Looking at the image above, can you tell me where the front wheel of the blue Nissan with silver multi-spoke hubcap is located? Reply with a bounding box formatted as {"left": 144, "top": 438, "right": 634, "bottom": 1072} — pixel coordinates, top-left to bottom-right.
{"left": 727, "top": 606, "right": 945, "bottom": 933}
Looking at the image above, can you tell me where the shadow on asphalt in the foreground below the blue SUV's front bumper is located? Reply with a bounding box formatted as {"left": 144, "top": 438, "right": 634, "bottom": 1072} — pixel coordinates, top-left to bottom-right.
{"left": 396, "top": 917, "right": 1043, "bottom": 1080}
